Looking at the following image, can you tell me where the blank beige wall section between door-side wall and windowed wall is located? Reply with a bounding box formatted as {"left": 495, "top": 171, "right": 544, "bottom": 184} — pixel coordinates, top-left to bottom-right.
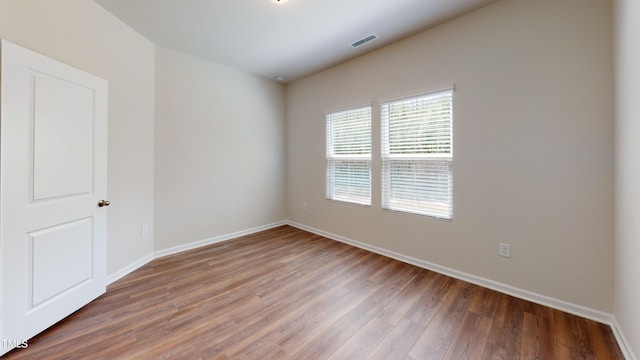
{"left": 155, "top": 47, "right": 285, "bottom": 250}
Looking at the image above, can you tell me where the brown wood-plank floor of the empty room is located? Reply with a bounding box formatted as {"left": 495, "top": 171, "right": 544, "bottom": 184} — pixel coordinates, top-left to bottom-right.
{"left": 5, "top": 226, "right": 623, "bottom": 360}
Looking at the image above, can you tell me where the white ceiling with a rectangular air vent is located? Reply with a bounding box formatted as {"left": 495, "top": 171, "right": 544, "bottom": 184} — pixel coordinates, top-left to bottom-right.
{"left": 95, "top": 0, "right": 495, "bottom": 82}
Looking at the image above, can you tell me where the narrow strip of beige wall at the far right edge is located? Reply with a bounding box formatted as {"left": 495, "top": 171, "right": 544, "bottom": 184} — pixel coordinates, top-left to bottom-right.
{"left": 615, "top": 0, "right": 640, "bottom": 356}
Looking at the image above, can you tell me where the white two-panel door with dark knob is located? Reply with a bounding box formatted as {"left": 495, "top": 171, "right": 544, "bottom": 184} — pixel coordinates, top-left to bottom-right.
{"left": 0, "top": 40, "right": 109, "bottom": 355}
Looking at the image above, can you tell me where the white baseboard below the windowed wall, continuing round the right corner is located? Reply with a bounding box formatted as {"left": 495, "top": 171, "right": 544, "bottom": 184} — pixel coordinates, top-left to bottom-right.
{"left": 286, "top": 221, "right": 638, "bottom": 360}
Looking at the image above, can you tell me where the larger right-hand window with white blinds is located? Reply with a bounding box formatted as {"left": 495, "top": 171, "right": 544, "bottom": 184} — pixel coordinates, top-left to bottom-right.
{"left": 381, "top": 89, "right": 453, "bottom": 219}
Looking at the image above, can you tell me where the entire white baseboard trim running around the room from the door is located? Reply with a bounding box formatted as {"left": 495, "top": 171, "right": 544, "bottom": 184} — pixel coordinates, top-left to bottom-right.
{"left": 107, "top": 220, "right": 638, "bottom": 360}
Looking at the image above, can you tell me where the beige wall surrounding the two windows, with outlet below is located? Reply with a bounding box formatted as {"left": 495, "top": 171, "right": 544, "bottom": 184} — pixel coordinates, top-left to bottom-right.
{"left": 287, "top": 0, "right": 614, "bottom": 312}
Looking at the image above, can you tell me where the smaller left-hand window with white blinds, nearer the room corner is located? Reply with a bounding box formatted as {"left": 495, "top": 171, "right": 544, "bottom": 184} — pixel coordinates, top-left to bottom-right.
{"left": 326, "top": 106, "right": 371, "bottom": 205}
